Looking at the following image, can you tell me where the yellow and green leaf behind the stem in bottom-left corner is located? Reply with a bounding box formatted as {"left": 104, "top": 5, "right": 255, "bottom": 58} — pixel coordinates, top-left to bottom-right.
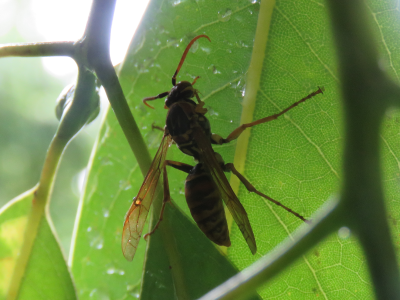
{"left": 0, "top": 189, "right": 76, "bottom": 299}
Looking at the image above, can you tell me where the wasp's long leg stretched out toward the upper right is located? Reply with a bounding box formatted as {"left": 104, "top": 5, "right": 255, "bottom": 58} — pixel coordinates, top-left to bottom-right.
{"left": 211, "top": 87, "right": 325, "bottom": 145}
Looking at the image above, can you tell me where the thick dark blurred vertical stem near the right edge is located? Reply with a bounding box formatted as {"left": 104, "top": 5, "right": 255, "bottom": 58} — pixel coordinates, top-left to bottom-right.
{"left": 328, "top": 0, "right": 400, "bottom": 299}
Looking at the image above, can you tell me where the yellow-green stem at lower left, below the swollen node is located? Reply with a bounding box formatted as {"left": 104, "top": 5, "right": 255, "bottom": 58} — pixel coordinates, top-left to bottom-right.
{"left": 7, "top": 136, "right": 68, "bottom": 300}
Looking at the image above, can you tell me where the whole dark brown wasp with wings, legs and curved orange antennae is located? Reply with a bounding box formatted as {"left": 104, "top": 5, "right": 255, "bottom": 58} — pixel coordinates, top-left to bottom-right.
{"left": 122, "top": 35, "right": 323, "bottom": 260}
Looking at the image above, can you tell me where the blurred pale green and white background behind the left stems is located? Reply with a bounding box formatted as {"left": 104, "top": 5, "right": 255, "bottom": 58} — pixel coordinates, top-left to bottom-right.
{"left": 0, "top": 0, "right": 148, "bottom": 255}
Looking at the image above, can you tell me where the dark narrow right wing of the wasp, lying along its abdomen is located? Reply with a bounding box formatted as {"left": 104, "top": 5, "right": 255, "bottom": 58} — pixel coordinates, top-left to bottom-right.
{"left": 193, "top": 126, "right": 257, "bottom": 254}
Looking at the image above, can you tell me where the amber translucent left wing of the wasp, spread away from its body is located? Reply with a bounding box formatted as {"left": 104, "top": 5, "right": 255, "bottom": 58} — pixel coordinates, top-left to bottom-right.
{"left": 122, "top": 135, "right": 171, "bottom": 261}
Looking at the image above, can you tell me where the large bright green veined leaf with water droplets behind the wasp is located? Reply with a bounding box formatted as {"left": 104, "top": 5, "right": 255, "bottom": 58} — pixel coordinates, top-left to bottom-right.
{"left": 71, "top": 0, "right": 400, "bottom": 299}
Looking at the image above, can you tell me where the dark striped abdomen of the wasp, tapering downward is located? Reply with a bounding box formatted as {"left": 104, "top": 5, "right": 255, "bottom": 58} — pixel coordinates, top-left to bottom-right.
{"left": 185, "top": 163, "right": 231, "bottom": 247}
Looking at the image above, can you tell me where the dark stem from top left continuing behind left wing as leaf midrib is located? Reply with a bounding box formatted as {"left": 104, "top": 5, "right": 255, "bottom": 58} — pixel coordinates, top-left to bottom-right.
{"left": 84, "top": 0, "right": 187, "bottom": 299}
